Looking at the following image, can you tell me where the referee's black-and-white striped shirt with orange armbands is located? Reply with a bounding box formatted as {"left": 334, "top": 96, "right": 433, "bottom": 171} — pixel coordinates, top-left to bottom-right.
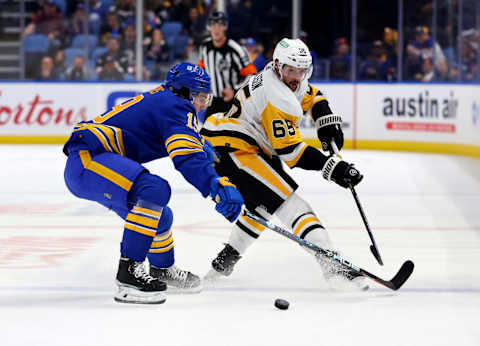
{"left": 198, "top": 38, "right": 257, "bottom": 97}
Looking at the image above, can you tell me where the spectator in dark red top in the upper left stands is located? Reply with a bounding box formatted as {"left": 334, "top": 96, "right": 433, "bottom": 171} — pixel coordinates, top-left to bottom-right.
{"left": 23, "top": 0, "right": 65, "bottom": 46}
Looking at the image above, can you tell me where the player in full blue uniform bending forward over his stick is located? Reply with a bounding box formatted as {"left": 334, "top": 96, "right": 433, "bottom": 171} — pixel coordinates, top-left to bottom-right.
{"left": 64, "top": 63, "right": 243, "bottom": 304}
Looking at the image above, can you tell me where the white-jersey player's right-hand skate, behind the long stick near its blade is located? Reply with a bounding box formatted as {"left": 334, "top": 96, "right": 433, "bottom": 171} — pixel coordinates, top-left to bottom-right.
{"left": 315, "top": 252, "right": 369, "bottom": 291}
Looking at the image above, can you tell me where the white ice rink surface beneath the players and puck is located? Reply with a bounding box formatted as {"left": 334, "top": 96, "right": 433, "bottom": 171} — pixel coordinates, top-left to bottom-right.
{"left": 0, "top": 146, "right": 480, "bottom": 346}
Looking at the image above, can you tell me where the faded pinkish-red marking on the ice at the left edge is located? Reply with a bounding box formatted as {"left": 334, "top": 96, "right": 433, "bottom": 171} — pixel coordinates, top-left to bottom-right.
{"left": 0, "top": 236, "right": 100, "bottom": 269}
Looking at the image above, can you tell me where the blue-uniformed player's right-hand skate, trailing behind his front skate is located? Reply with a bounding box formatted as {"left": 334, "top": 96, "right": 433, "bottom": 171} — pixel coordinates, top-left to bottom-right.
{"left": 150, "top": 265, "right": 202, "bottom": 293}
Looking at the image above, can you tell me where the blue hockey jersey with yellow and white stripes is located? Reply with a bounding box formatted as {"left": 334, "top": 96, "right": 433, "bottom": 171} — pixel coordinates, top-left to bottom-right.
{"left": 64, "top": 86, "right": 218, "bottom": 197}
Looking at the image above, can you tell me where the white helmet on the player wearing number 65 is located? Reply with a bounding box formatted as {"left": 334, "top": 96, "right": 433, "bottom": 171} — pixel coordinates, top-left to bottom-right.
{"left": 273, "top": 38, "right": 313, "bottom": 79}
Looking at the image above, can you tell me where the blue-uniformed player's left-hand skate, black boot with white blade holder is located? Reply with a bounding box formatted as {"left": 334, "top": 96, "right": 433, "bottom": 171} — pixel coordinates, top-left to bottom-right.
{"left": 114, "top": 256, "right": 167, "bottom": 304}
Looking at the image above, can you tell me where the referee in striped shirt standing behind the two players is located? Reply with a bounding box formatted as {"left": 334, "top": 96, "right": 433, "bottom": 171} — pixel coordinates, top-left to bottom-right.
{"left": 198, "top": 11, "right": 257, "bottom": 119}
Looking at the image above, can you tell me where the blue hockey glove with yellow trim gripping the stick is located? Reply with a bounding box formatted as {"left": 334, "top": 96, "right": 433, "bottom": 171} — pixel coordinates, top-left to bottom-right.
{"left": 210, "top": 177, "right": 243, "bottom": 222}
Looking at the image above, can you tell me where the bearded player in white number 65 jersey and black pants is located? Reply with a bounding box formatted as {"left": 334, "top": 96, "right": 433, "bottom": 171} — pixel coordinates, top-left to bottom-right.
{"left": 201, "top": 38, "right": 366, "bottom": 288}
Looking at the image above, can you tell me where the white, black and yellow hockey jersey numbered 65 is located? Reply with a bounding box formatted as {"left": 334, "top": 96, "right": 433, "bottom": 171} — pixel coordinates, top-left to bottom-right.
{"left": 201, "top": 65, "right": 329, "bottom": 167}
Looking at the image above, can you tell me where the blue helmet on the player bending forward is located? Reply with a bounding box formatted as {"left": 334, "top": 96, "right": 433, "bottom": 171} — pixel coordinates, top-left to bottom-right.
{"left": 165, "top": 62, "right": 210, "bottom": 98}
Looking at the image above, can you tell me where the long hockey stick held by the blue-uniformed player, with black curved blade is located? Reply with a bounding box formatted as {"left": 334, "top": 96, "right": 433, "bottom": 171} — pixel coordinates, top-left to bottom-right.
{"left": 243, "top": 209, "right": 414, "bottom": 291}
